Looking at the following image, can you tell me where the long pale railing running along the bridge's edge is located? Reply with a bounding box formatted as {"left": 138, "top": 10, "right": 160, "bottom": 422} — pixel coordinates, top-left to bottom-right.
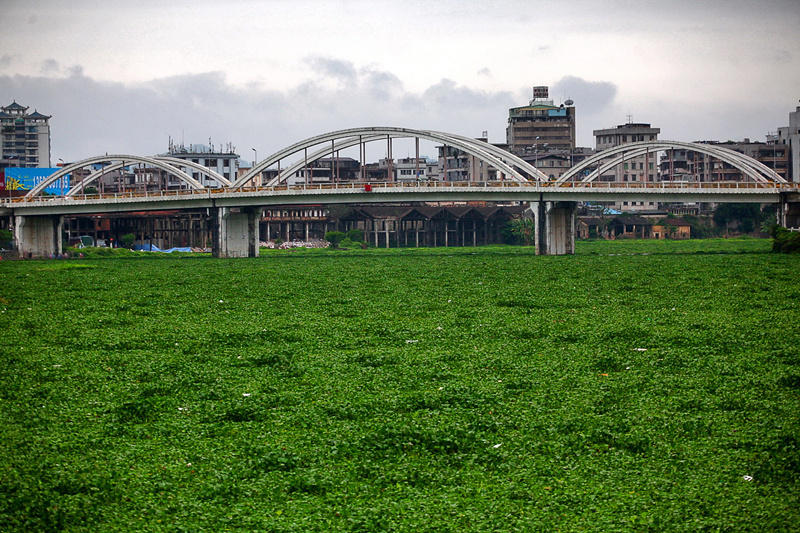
{"left": 0, "top": 180, "right": 797, "bottom": 206}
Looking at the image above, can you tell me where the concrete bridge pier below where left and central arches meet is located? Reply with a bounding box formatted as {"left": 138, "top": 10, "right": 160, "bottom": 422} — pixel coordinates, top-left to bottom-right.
{"left": 211, "top": 207, "right": 261, "bottom": 257}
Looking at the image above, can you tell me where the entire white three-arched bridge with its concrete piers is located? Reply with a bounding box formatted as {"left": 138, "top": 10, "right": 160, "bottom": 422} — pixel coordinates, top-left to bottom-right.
{"left": 8, "top": 126, "right": 791, "bottom": 256}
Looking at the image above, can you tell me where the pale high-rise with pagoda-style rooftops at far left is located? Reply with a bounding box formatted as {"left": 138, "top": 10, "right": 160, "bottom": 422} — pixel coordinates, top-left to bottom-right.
{"left": 0, "top": 102, "right": 51, "bottom": 168}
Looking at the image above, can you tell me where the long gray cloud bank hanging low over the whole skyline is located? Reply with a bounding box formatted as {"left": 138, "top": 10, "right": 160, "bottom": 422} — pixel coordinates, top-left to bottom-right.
{"left": 0, "top": 62, "right": 794, "bottom": 160}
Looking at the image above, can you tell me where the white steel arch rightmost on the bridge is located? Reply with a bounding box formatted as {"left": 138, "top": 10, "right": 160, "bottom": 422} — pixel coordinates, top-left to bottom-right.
{"left": 556, "top": 141, "right": 786, "bottom": 183}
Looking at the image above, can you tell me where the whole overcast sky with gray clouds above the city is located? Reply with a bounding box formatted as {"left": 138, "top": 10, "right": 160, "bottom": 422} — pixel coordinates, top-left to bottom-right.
{"left": 0, "top": 0, "right": 800, "bottom": 163}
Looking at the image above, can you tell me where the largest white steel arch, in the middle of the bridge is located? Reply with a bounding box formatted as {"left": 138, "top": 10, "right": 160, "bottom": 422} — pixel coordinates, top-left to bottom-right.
{"left": 231, "top": 127, "right": 547, "bottom": 188}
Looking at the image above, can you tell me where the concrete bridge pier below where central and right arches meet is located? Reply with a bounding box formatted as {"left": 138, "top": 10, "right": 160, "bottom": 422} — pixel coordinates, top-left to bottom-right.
{"left": 531, "top": 201, "right": 578, "bottom": 255}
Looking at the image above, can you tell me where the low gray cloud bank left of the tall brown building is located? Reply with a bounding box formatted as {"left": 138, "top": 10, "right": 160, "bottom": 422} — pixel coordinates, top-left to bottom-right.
{"left": 0, "top": 67, "right": 515, "bottom": 160}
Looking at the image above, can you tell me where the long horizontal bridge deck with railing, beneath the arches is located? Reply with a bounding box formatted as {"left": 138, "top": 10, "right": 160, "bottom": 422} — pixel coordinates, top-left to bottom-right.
{"left": 0, "top": 181, "right": 800, "bottom": 214}
